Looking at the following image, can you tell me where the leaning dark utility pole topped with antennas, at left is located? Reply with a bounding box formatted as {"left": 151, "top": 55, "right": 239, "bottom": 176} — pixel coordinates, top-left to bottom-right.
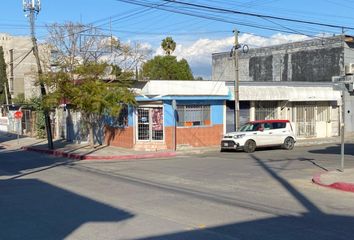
{"left": 23, "top": 0, "right": 54, "bottom": 149}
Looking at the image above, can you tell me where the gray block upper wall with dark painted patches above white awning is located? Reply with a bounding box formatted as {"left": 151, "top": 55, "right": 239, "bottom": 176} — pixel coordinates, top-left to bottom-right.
{"left": 212, "top": 36, "right": 348, "bottom": 82}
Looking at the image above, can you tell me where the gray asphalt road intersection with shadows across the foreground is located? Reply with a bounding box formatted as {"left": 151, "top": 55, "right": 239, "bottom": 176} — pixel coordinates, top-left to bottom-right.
{"left": 0, "top": 144, "right": 354, "bottom": 240}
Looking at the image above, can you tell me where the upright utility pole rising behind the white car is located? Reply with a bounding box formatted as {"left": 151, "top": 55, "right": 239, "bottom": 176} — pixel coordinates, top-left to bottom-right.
{"left": 233, "top": 29, "right": 240, "bottom": 131}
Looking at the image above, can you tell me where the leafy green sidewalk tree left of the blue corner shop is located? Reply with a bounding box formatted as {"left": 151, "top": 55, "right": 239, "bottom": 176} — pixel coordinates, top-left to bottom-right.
{"left": 42, "top": 63, "right": 135, "bottom": 147}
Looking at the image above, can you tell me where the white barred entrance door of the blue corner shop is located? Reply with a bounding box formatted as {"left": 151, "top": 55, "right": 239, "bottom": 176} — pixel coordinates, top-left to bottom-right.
{"left": 137, "top": 107, "right": 164, "bottom": 141}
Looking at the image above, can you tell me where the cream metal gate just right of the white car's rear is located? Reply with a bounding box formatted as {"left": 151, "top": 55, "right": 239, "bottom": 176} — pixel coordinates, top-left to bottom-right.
{"left": 293, "top": 103, "right": 316, "bottom": 137}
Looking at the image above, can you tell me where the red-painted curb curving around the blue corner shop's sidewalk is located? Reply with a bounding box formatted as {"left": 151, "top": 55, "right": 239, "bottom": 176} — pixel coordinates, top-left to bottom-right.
{"left": 21, "top": 147, "right": 177, "bottom": 161}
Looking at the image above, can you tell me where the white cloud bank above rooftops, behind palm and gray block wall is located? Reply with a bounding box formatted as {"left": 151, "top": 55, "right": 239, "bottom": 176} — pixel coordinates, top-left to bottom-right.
{"left": 154, "top": 33, "right": 309, "bottom": 79}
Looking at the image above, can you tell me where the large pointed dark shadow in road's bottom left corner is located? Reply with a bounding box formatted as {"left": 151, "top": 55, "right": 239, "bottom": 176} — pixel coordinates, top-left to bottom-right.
{"left": 0, "top": 179, "right": 133, "bottom": 240}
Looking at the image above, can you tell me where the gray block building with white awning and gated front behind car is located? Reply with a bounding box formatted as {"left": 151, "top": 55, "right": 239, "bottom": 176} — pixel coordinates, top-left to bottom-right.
{"left": 212, "top": 36, "right": 354, "bottom": 138}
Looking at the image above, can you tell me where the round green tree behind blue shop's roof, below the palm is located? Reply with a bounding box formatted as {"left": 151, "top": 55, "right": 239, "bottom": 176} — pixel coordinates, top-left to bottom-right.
{"left": 142, "top": 55, "right": 194, "bottom": 80}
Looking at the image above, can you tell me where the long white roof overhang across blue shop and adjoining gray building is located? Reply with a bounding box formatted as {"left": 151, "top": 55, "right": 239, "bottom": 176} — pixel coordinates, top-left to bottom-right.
{"left": 134, "top": 80, "right": 341, "bottom": 103}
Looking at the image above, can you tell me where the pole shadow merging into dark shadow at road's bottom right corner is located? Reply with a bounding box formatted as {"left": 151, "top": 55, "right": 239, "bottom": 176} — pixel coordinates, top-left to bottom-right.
{"left": 133, "top": 155, "right": 354, "bottom": 240}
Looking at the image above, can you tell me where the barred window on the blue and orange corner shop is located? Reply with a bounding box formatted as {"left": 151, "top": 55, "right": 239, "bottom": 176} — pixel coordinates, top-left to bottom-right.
{"left": 177, "top": 105, "right": 211, "bottom": 127}
